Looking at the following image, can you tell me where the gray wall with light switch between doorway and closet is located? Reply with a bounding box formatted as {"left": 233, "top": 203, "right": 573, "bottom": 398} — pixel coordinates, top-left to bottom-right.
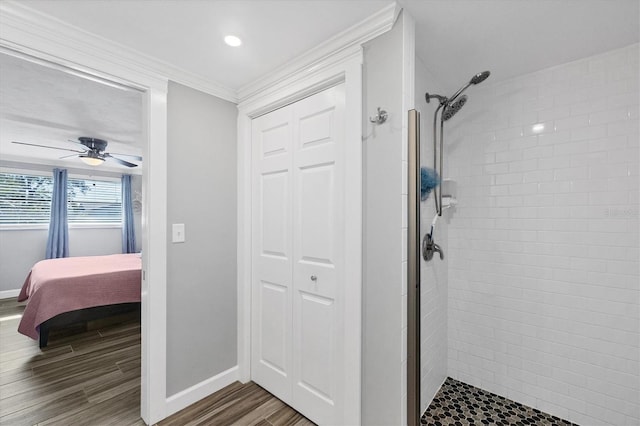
{"left": 167, "top": 82, "right": 237, "bottom": 396}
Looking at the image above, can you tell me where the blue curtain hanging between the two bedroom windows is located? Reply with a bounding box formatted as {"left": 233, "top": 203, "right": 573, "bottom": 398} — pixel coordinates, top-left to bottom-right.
{"left": 46, "top": 169, "right": 69, "bottom": 259}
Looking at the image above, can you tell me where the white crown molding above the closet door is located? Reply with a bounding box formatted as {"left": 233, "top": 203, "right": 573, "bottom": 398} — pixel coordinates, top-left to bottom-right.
{"left": 237, "top": 2, "right": 402, "bottom": 103}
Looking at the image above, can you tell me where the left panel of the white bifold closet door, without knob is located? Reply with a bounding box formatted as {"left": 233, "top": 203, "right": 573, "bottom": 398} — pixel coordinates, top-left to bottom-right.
{"left": 251, "top": 108, "right": 293, "bottom": 401}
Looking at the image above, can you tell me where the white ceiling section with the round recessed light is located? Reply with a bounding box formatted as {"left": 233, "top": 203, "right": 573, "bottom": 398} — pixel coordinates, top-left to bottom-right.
{"left": 21, "top": 0, "right": 391, "bottom": 90}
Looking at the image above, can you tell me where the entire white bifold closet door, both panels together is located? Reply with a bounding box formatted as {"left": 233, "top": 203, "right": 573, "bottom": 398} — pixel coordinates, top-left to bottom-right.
{"left": 251, "top": 84, "right": 345, "bottom": 425}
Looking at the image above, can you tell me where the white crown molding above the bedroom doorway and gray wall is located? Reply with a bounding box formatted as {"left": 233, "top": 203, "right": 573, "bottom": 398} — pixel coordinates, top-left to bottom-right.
{"left": 0, "top": 0, "right": 237, "bottom": 103}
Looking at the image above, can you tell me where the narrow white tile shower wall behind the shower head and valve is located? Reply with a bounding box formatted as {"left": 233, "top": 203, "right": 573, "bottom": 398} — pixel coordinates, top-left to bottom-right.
{"left": 415, "top": 58, "right": 451, "bottom": 413}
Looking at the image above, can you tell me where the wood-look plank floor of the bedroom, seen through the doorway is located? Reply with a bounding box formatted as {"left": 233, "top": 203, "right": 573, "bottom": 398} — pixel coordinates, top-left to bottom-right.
{"left": 0, "top": 299, "right": 144, "bottom": 426}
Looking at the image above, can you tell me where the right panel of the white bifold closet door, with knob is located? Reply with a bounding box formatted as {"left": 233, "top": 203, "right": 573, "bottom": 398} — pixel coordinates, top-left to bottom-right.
{"left": 293, "top": 85, "right": 345, "bottom": 424}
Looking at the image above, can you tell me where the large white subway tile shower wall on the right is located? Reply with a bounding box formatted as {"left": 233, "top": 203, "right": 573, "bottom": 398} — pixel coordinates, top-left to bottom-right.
{"left": 444, "top": 44, "right": 640, "bottom": 426}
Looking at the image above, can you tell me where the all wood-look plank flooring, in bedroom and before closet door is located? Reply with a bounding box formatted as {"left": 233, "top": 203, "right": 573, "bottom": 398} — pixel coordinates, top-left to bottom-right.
{"left": 0, "top": 298, "right": 313, "bottom": 426}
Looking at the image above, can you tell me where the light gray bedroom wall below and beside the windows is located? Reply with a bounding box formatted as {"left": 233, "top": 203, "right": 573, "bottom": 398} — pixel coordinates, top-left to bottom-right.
{"left": 0, "top": 169, "right": 142, "bottom": 291}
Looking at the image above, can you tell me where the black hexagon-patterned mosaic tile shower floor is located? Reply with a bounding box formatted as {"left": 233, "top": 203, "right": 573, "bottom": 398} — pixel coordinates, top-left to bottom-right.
{"left": 420, "top": 377, "right": 577, "bottom": 426}
